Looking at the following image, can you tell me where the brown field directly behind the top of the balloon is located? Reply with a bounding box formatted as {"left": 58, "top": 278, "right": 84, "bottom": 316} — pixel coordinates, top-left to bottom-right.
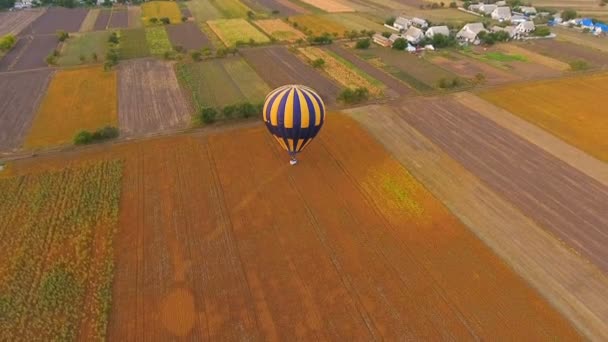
{"left": 241, "top": 46, "right": 340, "bottom": 104}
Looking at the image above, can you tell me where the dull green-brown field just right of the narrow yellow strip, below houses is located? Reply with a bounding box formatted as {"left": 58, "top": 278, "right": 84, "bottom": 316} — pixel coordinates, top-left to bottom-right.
{"left": 355, "top": 46, "right": 457, "bottom": 92}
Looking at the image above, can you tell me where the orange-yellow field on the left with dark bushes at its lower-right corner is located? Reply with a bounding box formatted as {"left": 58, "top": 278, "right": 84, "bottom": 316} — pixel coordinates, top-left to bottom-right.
{"left": 25, "top": 67, "right": 118, "bottom": 148}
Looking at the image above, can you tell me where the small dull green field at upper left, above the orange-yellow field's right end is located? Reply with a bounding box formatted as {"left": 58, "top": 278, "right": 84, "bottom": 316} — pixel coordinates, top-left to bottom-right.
{"left": 57, "top": 31, "right": 110, "bottom": 66}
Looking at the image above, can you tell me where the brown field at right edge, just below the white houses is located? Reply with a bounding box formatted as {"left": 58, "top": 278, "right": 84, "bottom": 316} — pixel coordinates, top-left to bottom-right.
{"left": 521, "top": 39, "right": 608, "bottom": 68}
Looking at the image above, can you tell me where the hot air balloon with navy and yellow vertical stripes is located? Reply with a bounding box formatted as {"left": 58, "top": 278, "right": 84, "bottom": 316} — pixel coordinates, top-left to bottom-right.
{"left": 263, "top": 84, "right": 325, "bottom": 165}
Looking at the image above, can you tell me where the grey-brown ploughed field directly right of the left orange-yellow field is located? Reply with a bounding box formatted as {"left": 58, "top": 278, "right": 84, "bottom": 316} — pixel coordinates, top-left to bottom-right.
{"left": 118, "top": 59, "right": 191, "bottom": 135}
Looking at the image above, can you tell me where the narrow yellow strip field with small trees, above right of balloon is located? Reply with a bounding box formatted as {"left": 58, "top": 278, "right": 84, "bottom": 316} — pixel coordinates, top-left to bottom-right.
{"left": 298, "top": 46, "right": 384, "bottom": 97}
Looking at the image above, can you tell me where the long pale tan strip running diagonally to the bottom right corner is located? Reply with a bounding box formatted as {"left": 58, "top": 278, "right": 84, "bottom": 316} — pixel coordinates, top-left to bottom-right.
{"left": 349, "top": 103, "right": 608, "bottom": 340}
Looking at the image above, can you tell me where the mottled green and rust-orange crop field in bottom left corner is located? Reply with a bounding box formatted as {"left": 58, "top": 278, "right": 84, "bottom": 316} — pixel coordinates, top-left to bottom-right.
{"left": 0, "top": 161, "right": 122, "bottom": 341}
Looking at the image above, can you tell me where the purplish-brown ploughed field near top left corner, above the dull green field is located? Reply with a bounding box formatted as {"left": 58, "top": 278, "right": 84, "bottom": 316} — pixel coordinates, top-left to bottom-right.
{"left": 23, "top": 7, "right": 89, "bottom": 35}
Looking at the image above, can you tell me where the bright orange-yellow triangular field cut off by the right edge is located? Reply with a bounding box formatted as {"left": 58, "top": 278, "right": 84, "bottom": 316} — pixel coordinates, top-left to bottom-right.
{"left": 480, "top": 73, "right": 608, "bottom": 162}
